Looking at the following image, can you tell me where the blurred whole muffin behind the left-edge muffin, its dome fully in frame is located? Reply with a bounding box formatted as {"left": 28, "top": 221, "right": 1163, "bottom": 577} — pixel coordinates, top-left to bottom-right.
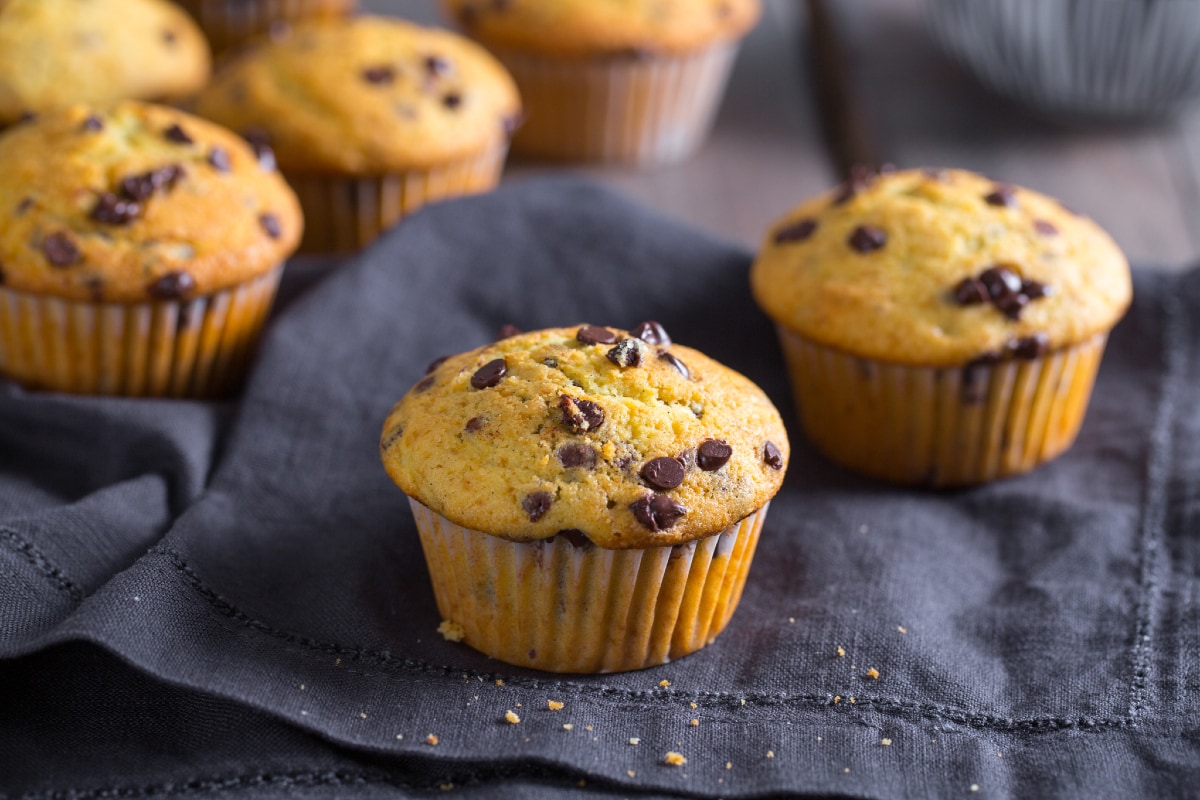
{"left": 197, "top": 17, "right": 521, "bottom": 252}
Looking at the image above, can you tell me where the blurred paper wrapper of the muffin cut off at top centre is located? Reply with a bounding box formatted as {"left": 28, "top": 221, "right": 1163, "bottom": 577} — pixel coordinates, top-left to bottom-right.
{"left": 497, "top": 42, "right": 739, "bottom": 166}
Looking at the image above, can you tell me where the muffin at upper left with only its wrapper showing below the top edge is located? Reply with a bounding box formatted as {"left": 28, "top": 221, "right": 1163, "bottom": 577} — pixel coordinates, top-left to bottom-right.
{"left": 178, "top": 0, "right": 358, "bottom": 54}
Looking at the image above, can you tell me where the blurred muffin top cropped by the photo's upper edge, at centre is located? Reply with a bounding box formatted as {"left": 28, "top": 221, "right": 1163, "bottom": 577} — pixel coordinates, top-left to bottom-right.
{"left": 443, "top": 0, "right": 760, "bottom": 56}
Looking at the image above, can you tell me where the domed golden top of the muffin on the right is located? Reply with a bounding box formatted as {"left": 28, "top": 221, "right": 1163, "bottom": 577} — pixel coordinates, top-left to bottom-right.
{"left": 750, "top": 170, "right": 1133, "bottom": 367}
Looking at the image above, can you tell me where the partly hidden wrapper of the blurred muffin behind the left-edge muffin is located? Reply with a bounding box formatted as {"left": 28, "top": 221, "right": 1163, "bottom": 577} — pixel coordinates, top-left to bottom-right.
{"left": 294, "top": 143, "right": 508, "bottom": 253}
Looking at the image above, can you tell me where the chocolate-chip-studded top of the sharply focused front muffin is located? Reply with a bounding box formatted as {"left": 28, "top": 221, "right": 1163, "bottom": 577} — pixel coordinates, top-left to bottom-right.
{"left": 379, "top": 323, "right": 790, "bottom": 549}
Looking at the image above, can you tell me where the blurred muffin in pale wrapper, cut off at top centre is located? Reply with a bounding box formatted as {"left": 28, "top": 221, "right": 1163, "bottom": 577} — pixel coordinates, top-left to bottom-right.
{"left": 443, "top": 0, "right": 760, "bottom": 166}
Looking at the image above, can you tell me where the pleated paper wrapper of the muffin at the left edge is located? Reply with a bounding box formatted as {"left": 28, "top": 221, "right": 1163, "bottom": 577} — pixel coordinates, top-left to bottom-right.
{"left": 0, "top": 266, "right": 283, "bottom": 397}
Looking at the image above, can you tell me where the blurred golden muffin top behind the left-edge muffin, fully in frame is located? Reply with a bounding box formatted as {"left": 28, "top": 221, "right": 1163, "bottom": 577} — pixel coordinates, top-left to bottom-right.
{"left": 197, "top": 17, "right": 521, "bottom": 175}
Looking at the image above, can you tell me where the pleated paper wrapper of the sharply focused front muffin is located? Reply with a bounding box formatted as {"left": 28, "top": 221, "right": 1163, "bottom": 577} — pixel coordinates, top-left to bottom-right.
{"left": 409, "top": 499, "right": 768, "bottom": 673}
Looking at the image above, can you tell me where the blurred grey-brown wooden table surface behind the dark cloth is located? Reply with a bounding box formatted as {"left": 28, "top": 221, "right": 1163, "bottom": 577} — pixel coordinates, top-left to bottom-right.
{"left": 364, "top": 0, "right": 1200, "bottom": 270}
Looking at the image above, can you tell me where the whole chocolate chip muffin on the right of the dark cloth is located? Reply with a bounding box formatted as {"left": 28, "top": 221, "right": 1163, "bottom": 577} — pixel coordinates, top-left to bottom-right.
{"left": 751, "top": 170, "right": 1132, "bottom": 486}
